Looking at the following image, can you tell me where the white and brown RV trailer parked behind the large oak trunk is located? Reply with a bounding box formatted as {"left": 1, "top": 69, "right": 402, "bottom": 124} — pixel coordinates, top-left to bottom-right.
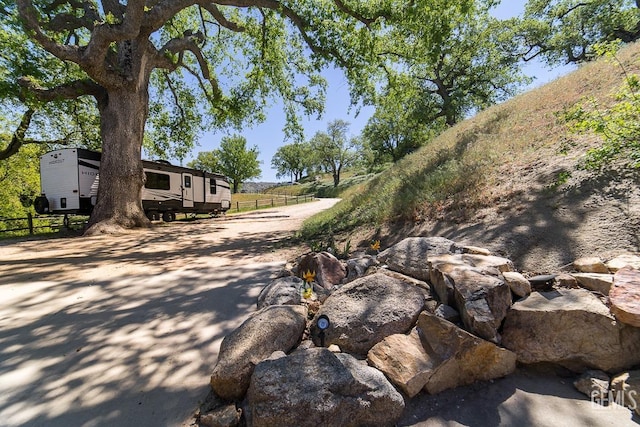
{"left": 34, "top": 148, "right": 231, "bottom": 221}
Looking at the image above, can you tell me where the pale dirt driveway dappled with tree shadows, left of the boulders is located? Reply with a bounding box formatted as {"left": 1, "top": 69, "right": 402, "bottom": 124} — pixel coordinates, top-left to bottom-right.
{"left": 0, "top": 199, "right": 336, "bottom": 427}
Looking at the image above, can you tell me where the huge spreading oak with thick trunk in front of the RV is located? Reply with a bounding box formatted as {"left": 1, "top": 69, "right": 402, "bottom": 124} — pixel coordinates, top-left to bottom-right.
{"left": 0, "top": 0, "right": 473, "bottom": 233}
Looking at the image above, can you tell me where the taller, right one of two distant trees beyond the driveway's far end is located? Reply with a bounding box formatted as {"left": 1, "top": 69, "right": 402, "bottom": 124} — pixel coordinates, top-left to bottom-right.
{"left": 310, "top": 119, "right": 355, "bottom": 187}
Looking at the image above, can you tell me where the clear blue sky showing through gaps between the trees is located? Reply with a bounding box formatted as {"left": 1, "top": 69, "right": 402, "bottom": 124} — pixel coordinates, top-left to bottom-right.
{"left": 184, "top": 0, "right": 572, "bottom": 182}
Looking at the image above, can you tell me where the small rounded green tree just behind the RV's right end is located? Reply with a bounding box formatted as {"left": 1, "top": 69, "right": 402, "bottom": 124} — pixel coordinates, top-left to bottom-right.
{"left": 214, "top": 135, "right": 262, "bottom": 193}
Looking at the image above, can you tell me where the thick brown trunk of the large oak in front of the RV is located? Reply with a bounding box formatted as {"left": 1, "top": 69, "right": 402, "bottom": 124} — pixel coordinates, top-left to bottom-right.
{"left": 85, "top": 86, "right": 150, "bottom": 235}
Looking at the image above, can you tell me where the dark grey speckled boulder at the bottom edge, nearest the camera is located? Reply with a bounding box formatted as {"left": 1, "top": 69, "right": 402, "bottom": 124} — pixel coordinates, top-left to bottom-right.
{"left": 244, "top": 348, "right": 404, "bottom": 427}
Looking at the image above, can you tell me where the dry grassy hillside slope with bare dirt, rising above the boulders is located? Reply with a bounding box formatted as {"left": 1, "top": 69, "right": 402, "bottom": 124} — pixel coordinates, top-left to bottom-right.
{"left": 305, "top": 44, "right": 640, "bottom": 272}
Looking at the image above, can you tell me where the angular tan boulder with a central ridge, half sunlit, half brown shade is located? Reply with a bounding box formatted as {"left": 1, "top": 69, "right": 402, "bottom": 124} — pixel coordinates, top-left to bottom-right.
{"left": 367, "top": 313, "right": 516, "bottom": 397}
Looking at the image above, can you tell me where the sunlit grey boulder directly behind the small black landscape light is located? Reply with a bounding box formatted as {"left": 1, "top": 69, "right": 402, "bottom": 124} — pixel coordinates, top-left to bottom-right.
{"left": 311, "top": 273, "right": 425, "bottom": 355}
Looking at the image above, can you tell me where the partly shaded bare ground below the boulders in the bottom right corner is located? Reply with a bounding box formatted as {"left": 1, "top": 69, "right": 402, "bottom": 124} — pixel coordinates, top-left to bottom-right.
{"left": 397, "top": 367, "right": 638, "bottom": 427}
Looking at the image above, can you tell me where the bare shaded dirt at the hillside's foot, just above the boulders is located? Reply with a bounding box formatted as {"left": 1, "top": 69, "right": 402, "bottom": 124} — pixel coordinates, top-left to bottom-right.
{"left": 348, "top": 166, "right": 640, "bottom": 276}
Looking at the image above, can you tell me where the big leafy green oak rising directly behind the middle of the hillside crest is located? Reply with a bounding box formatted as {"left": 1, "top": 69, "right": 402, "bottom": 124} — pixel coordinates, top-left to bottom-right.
{"left": 376, "top": 0, "right": 527, "bottom": 129}
